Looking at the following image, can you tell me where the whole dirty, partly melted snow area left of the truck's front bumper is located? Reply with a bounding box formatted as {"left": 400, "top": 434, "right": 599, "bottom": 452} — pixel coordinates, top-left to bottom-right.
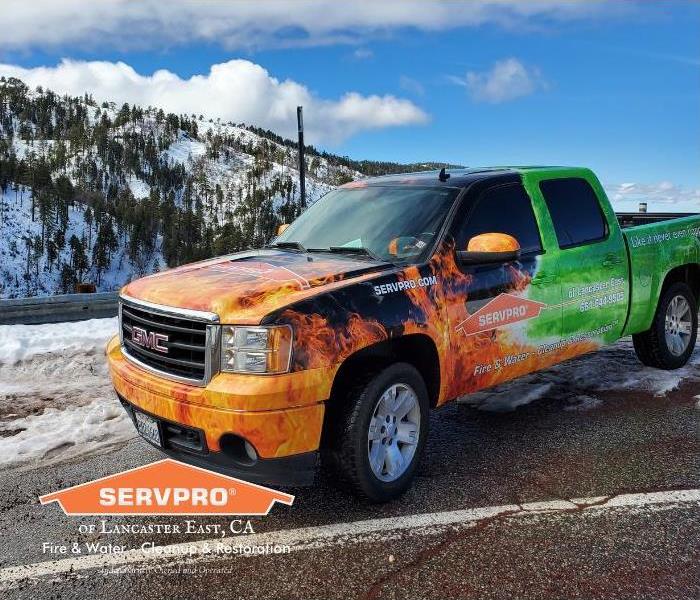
{"left": 0, "top": 319, "right": 136, "bottom": 467}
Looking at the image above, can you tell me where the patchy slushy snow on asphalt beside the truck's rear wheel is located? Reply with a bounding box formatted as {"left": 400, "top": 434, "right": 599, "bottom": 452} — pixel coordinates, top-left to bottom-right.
{"left": 459, "top": 338, "right": 700, "bottom": 412}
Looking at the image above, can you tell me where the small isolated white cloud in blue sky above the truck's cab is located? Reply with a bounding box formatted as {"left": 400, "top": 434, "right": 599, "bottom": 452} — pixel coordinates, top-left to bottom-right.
{"left": 449, "top": 58, "right": 547, "bottom": 104}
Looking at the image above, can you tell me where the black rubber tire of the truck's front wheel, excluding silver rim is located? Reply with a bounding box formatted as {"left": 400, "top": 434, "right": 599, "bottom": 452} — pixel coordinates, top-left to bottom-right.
{"left": 321, "top": 363, "right": 430, "bottom": 502}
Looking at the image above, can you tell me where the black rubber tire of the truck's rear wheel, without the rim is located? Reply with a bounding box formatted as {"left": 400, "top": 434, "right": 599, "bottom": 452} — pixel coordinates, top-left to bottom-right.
{"left": 632, "top": 282, "right": 698, "bottom": 371}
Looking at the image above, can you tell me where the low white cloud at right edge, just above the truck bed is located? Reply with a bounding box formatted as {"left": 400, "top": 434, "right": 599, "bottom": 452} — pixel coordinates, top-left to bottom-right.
{"left": 605, "top": 181, "right": 700, "bottom": 213}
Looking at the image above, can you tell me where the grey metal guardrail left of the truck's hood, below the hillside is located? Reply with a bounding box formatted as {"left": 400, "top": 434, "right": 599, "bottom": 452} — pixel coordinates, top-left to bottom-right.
{"left": 0, "top": 292, "right": 119, "bottom": 325}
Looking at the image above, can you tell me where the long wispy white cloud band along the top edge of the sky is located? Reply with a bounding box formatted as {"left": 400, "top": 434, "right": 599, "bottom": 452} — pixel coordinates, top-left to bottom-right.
{"left": 0, "top": 0, "right": 630, "bottom": 50}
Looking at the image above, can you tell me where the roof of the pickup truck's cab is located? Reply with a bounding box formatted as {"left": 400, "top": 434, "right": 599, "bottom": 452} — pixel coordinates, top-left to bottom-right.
{"left": 360, "top": 165, "right": 572, "bottom": 188}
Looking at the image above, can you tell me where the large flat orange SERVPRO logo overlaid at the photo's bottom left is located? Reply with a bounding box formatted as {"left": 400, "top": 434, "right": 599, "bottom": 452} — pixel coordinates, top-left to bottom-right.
{"left": 39, "top": 458, "right": 294, "bottom": 515}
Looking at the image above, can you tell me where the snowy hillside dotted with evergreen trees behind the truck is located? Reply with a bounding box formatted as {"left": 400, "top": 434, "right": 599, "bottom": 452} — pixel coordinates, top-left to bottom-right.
{"left": 0, "top": 78, "right": 454, "bottom": 298}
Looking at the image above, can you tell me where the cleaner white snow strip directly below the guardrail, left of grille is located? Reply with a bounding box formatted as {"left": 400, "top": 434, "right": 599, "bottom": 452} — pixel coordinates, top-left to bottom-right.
{"left": 0, "top": 317, "right": 118, "bottom": 364}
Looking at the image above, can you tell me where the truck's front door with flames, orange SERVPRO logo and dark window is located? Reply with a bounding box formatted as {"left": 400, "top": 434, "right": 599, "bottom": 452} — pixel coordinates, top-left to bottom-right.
{"left": 446, "top": 177, "right": 562, "bottom": 397}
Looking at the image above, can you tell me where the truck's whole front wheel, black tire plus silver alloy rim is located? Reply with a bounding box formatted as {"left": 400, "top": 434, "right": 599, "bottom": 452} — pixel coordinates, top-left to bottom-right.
{"left": 324, "top": 363, "right": 429, "bottom": 502}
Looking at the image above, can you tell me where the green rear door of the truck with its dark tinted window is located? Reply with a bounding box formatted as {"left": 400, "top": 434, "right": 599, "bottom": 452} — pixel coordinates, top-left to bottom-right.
{"left": 539, "top": 177, "right": 629, "bottom": 354}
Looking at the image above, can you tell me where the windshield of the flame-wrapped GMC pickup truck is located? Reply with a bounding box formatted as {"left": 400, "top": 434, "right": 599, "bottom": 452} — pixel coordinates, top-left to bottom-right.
{"left": 272, "top": 186, "right": 459, "bottom": 262}
